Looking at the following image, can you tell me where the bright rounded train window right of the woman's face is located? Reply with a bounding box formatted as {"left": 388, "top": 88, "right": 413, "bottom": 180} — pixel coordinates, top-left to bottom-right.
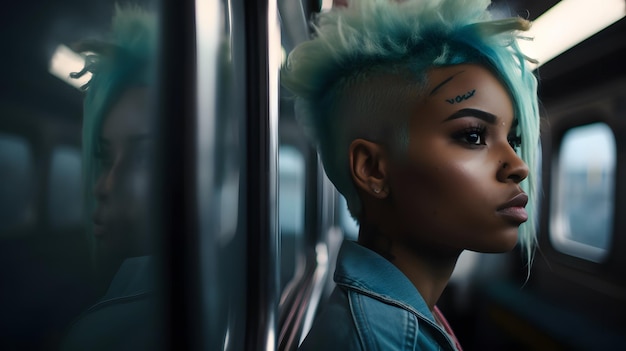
{"left": 550, "top": 123, "right": 616, "bottom": 262}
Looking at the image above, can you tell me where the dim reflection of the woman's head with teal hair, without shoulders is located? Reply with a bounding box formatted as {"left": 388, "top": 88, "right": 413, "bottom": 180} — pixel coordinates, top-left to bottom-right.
{"left": 76, "top": 7, "right": 156, "bottom": 264}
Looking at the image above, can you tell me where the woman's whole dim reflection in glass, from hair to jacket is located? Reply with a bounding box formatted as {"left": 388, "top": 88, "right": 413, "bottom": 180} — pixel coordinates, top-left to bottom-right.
{"left": 62, "top": 6, "right": 162, "bottom": 350}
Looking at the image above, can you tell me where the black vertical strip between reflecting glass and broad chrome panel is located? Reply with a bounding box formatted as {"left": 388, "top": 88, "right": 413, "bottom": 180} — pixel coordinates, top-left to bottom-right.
{"left": 155, "top": 0, "right": 202, "bottom": 350}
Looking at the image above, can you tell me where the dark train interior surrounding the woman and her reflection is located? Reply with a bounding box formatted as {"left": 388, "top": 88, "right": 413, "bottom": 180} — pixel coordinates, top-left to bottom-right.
{"left": 0, "top": 0, "right": 626, "bottom": 350}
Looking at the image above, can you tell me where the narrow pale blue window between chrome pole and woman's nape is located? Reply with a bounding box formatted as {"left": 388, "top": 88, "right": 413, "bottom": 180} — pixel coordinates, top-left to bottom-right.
{"left": 278, "top": 146, "right": 306, "bottom": 291}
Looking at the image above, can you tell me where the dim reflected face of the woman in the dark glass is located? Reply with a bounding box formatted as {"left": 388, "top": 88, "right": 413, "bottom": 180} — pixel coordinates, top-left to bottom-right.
{"left": 93, "top": 88, "right": 154, "bottom": 258}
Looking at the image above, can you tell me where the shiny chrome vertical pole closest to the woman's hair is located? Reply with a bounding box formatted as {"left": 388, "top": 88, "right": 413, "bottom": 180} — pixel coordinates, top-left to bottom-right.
{"left": 245, "top": 0, "right": 280, "bottom": 351}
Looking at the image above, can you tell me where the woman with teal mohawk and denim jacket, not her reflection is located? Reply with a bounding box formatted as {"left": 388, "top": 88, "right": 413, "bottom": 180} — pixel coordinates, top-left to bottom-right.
{"left": 282, "top": 0, "right": 539, "bottom": 350}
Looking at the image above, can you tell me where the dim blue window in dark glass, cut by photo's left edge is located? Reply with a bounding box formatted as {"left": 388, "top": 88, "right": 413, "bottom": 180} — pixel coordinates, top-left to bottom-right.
{"left": 0, "top": 133, "right": 35, "bottom": 233}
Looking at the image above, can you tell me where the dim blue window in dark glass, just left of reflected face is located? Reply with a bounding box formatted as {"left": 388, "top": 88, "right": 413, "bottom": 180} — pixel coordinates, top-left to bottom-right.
{"left": 48, "top": 146, "right": 83, "bottom": 227}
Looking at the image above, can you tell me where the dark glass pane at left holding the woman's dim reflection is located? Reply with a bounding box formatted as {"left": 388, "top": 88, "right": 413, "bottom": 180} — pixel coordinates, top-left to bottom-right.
{"left": 0, "top": 0, "right": 166, "bottom": 350}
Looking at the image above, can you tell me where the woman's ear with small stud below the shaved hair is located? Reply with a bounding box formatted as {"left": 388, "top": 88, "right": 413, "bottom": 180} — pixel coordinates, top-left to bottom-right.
{"left": 350, "top": 139, "right": 389, "bottom": 199}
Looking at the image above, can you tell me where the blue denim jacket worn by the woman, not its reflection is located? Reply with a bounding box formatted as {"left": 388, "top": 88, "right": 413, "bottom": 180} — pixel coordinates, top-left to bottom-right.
{"left": 300, "top": 241, "right": 457, "bottom": 351}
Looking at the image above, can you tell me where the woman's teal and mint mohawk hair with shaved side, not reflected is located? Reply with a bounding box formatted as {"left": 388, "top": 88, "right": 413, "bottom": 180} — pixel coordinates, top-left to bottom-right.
{"left": 281, "top": 0, "right": 538, "bottom": 255}
